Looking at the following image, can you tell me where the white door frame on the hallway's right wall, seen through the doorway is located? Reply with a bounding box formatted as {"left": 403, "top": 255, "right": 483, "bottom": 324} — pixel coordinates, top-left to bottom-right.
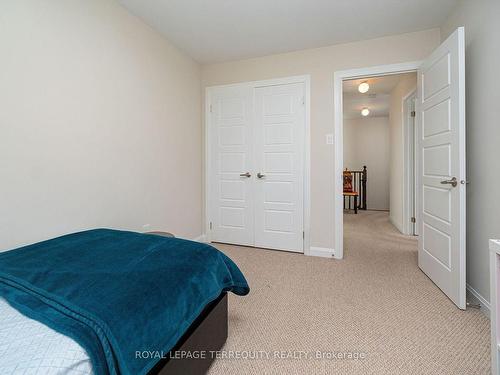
{"left": 401, "top": 88, "right": 419, "bottom": 236}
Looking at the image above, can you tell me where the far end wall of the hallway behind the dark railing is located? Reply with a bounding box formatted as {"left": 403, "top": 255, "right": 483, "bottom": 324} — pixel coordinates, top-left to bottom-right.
{"left": 344, "top": 117, "right": 390, "bottom": 210}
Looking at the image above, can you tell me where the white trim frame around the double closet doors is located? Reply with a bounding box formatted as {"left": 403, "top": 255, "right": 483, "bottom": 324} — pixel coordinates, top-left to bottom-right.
{"left": 202, "top": 74, "right": 311, "bottom": 255}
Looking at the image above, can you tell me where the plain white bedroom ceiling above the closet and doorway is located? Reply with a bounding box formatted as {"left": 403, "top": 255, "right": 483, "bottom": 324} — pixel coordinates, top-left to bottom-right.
{"left": 119, "top": 0, "right": 456, "bottom": 63}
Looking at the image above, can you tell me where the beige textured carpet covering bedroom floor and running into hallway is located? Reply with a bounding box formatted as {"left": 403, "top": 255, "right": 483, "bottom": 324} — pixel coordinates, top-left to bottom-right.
{"left": 209, "top": 211, "right": 490, "bottom": 375}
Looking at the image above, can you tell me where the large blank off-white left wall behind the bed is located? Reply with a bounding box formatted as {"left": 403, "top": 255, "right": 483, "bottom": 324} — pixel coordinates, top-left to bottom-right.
{"left": 0, "top": 0, "right": 202, "bottom": 250}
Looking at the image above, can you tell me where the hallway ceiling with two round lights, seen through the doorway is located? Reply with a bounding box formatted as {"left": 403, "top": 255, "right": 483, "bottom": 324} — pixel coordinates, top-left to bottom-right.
{"left": 343, "top": 73, "right": 417, "bottom": 119}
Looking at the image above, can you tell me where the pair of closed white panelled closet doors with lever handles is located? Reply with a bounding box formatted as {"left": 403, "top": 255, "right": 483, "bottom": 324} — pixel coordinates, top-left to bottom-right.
{"left": 207, "top": 83, "right": 305, "bottom": 252}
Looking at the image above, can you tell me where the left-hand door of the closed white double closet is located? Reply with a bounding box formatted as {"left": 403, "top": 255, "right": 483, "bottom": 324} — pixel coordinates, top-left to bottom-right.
{"left": 207, "top": 86, "right": 254, "bottom": 246}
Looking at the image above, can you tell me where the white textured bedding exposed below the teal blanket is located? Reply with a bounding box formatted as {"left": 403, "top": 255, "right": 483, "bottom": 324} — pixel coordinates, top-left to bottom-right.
{"left": 0, "top": 297, "right": 93, "bottom": 375}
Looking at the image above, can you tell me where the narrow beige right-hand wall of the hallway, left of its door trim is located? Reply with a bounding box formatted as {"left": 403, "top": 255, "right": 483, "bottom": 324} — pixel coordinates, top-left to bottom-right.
{"left": 389, "top": 73, "right": 417, "bottom": 232}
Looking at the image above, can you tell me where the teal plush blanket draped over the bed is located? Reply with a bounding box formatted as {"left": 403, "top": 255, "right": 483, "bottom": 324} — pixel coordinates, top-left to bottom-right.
{"left": 0, "top": 229, "right": 249, "bottom": 375}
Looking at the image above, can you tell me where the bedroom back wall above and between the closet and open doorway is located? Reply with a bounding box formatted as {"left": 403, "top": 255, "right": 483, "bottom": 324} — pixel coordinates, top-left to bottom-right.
{"left": 202, "top": 29, "right": 440, "bottom": 248}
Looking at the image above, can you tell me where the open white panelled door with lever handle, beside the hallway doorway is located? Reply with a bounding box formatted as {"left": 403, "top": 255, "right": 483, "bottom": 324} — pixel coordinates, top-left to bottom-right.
{"left": 417, "top": 28, "right": 466, "bottom": 309}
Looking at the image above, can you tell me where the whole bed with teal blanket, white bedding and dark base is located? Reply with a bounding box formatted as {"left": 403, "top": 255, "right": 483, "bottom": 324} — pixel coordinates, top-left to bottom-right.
{"left": 0, "top": 229, "right": 249, "bottom": 375}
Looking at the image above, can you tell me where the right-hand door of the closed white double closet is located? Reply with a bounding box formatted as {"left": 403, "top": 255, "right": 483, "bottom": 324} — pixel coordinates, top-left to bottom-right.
{"left": 254, "top": 83, "right": 305, "bottom": 252}
